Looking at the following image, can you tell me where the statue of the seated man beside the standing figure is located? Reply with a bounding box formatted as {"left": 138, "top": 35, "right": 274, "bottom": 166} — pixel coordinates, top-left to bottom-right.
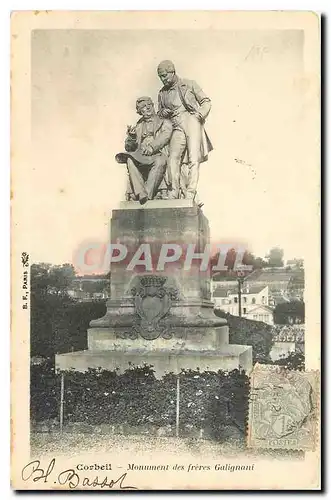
{"left": 115, "top": 97, "right": 172, "bottom": 204}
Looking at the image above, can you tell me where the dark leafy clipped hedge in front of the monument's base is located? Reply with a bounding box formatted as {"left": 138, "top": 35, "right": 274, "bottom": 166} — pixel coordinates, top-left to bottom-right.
{"left": 30, "top": 363, "right": 249, "bottom": 437}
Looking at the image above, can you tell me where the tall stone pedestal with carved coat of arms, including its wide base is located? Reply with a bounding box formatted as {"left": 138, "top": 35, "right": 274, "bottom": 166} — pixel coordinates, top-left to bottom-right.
{"left": 56, "top": 200, "right": 252, "bottom": 376}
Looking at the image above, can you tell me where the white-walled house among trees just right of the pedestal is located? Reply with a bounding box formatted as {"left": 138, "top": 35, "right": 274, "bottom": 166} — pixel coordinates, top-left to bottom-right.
{"left": 212, "top": 283, "right": 273, "bottom": 325}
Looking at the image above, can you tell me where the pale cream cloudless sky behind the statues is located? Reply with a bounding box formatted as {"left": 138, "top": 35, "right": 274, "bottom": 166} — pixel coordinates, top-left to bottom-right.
{"left": 26, "top": 29, "right": 318, "bottom": 264}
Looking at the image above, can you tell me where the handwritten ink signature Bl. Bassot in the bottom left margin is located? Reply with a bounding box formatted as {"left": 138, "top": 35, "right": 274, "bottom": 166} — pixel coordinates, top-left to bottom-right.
{"left": 21, "top": 458, "right": 138, "bottom": 490}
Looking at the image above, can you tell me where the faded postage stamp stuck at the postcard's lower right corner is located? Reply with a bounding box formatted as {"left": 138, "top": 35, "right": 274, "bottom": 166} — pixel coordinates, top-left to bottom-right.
{"left": 248, "top": 364, "right": 319, "bottom": 450}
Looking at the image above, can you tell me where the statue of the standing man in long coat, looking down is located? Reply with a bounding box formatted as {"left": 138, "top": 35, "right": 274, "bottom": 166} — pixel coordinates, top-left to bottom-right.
{"left": 157, "top": 61, "right": 213, "bottom": 199}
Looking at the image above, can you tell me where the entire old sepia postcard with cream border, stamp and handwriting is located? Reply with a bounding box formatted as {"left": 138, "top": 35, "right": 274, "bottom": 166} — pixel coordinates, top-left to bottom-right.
{"left": 11, "top": 11, "right": 321, "bottom": 491}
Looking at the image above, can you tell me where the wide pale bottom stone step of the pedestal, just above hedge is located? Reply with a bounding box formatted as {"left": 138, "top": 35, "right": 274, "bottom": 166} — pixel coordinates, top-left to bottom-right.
{"left": 55, "top": 344, "right": 252, "bottom": 378}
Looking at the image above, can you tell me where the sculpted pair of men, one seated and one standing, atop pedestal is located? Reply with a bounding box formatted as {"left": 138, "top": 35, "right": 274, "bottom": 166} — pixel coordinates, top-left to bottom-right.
{"left": 116, "top": 61, "right": 213, "bottom": 204}
